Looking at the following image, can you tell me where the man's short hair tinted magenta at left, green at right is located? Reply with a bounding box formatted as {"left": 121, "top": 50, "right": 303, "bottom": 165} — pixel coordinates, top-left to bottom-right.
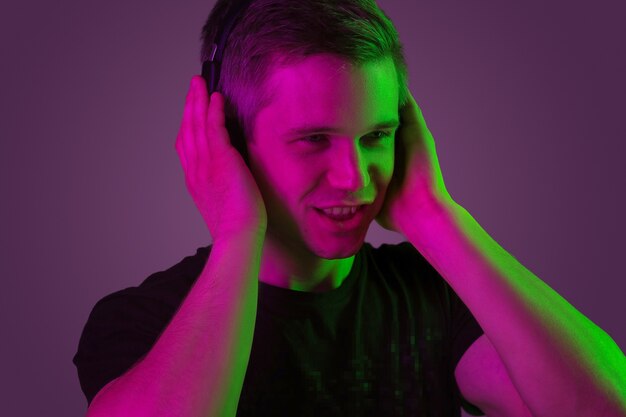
{"left": 201, "top": 0, "right": 408, "bottom": 140}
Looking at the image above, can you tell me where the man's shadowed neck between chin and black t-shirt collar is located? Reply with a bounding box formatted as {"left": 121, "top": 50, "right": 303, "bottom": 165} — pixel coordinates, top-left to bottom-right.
{"left": 259, "top": 232, "right": 354, "bottom": 292}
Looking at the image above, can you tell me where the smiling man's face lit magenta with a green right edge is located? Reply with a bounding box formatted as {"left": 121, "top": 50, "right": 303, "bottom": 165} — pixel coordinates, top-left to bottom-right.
{"left": 248, "top": 55, "right": 398, "bottom": 259}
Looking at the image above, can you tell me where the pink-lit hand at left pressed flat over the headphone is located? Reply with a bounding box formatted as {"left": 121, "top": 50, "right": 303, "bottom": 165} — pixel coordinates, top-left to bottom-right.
{"left": 176, "top": 76, "right": 267, "bottom": 242}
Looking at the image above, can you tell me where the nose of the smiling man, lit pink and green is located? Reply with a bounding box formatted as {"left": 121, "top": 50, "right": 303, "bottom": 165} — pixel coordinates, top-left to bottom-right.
{"left": 328, "top": 141, "right": 370, "bottom": 192}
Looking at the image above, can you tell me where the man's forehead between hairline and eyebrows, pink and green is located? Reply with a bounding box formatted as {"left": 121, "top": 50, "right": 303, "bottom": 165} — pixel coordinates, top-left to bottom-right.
{"left": 264, "top": 55, "right": 399, "bottom": 129}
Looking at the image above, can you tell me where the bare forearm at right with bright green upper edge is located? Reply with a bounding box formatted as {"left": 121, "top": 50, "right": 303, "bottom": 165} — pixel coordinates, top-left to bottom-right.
{"left": 406, "top": 203, "right": 626, "bottom": 417}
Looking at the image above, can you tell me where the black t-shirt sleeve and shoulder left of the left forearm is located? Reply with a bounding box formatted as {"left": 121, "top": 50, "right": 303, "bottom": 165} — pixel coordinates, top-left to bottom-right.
{"left": 73, "top": 246, "right": 211, "bottom": 404}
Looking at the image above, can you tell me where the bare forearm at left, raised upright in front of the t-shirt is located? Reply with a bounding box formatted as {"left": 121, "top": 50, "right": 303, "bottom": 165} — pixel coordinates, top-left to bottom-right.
{"left": 88, "top": 234, "right": 263, "bottom": 417}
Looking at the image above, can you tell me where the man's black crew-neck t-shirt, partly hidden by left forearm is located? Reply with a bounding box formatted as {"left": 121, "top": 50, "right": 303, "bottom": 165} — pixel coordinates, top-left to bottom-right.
{"left": 74, "top": 242, "right": 483, "bottom": 417}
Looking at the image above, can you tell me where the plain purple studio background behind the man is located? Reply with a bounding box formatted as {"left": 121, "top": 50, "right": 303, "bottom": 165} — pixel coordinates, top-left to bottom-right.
{"left": 0, "top": 0, "right": 626, "bottom": 417}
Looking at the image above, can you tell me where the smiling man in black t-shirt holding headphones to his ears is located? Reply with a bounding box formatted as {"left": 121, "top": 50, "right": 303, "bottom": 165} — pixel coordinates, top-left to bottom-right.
{"left": 75, "top": 0, "right": 626, "bottom": 417}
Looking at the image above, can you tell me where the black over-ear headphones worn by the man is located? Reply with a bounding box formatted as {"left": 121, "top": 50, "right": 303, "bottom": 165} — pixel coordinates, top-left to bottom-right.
{"left": 202, "top": 0, "right": 254, "bottom": 166}
